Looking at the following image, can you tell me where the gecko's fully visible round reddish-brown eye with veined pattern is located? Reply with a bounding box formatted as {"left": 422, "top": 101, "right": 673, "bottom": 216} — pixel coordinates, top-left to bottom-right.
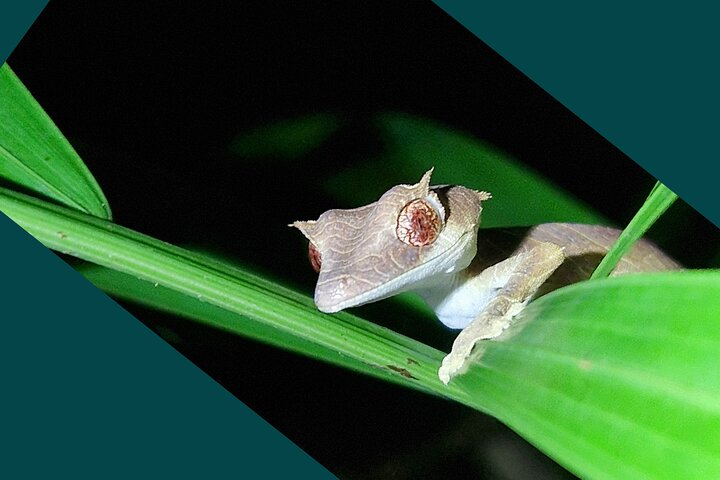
{"left": 395, "top": 197, "right": 444, "bottom": 247}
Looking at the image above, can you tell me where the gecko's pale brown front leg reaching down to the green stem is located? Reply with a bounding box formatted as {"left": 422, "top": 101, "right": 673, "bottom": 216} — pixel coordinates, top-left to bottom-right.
{"left": 438, "top": 243, "right": 565, "bottom": 385}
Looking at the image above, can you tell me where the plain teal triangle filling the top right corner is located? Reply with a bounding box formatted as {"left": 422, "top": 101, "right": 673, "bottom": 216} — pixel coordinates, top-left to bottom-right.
{"left": 435, "top": 0, "right": 720, "bottom": 226}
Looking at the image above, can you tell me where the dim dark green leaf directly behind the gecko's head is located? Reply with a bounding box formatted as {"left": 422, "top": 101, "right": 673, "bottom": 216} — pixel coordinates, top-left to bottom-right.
{"left": 326, "top": 113, "right": 608, "bottom": 228}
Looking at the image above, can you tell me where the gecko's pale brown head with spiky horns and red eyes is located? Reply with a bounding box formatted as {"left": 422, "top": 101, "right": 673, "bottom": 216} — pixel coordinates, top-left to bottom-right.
{"left": 291, "top": 169, "right": 490, "bottom": 313}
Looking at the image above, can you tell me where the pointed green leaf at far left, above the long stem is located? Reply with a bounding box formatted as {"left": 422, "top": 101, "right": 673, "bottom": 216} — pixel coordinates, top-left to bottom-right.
{"left": 0, "top": 64, "right": 111, "bottom": 218}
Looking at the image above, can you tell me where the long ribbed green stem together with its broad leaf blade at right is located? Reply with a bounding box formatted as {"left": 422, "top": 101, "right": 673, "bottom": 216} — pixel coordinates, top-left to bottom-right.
{"left": 0, "top": 186, "right": 720, "bottom": 478}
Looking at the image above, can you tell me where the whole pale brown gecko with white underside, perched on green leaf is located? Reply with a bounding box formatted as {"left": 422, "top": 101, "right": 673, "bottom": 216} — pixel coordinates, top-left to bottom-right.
{"left": 290, "top": 169, "right": 680, "bottom": 385}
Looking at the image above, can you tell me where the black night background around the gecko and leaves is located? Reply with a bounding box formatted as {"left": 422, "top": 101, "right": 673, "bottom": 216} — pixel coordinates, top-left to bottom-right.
{"left": 9, "top": 1, "right": 719, "bottom": 478}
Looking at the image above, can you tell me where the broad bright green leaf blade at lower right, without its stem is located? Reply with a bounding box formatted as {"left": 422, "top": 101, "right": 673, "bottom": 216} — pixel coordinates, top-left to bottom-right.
{"left": 460, "top": 271, "right": 720, "bottom": 478}
